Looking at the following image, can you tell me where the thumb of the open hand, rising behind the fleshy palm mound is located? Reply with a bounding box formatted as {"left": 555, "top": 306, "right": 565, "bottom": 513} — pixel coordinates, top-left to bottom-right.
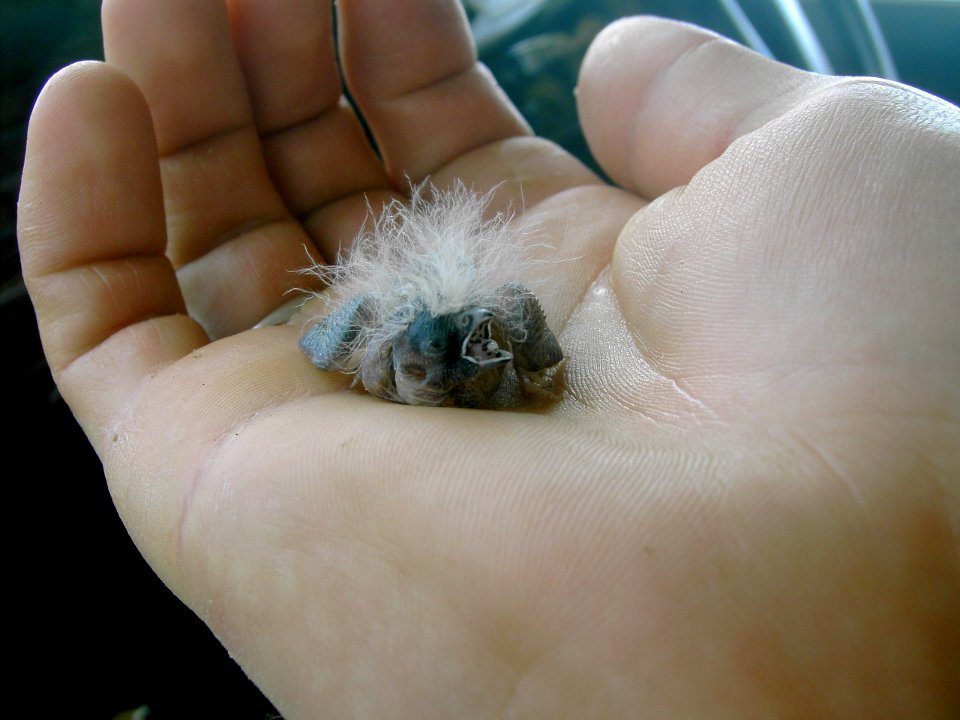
{"left": 577, "top": 17, "right": 836, "bottom": 198}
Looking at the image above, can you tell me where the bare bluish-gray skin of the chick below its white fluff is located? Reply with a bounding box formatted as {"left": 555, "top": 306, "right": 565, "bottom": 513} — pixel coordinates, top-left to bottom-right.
{"left": 300, "top": 283, "right": 563, "bottom": 407}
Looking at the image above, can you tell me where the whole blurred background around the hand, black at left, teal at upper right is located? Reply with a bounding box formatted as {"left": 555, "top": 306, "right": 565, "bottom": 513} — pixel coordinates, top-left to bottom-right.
{"left": 0, "top": 0, "right": 960, "bottom": 720}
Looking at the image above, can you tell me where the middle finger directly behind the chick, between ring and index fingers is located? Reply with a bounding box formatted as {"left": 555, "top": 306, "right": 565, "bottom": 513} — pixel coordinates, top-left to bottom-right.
{"left": 228, "top": 0, "right": 393, "bottom": 250}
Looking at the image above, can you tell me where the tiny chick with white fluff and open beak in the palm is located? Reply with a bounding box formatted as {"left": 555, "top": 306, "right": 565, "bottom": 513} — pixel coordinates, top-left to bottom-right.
{"left": 300, "top": 184, "right": 563, "bottom": 407}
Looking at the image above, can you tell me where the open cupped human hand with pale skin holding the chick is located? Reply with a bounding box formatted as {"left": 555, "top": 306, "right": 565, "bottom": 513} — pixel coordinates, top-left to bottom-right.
{"left": 19, "top": 0, "right": 960, "bottom": 719}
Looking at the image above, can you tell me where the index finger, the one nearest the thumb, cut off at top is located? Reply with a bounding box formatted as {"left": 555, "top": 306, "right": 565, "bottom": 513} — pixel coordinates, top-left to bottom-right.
{"left": 337, "top": 0, "right": 530, "bottom": 185}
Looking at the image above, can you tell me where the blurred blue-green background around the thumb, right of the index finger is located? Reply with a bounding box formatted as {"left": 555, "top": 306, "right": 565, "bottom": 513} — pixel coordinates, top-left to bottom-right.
{"left": 464, "top": 0, "right": 960, "bottom": 176}
